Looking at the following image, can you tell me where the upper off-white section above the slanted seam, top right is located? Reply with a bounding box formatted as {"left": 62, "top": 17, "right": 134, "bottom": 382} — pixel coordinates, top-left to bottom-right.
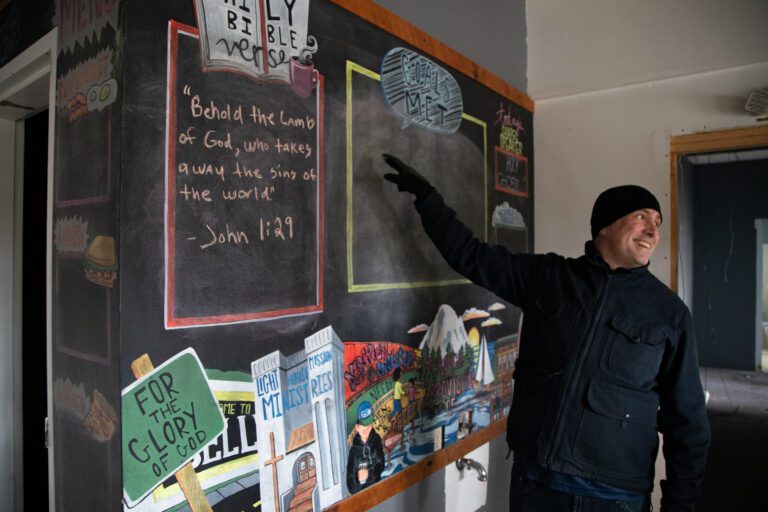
{"left": 526, "top": 0, "right": 768, "bottom": 101}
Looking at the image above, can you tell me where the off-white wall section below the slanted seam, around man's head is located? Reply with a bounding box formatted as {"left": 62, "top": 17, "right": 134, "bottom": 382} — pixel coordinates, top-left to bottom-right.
{"left": 534, "top": 60, "right": 768, "bottom": 284}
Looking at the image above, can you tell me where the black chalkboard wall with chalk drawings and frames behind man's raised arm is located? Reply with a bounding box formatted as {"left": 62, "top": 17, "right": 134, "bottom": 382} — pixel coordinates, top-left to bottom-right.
{"left": 53, "top": 0, "right": 535, "bottom": 510}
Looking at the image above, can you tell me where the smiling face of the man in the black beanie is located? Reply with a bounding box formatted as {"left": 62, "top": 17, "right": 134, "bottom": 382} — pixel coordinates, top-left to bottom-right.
{"left": 595, "top": 208, "right": 661, "bottom": 269}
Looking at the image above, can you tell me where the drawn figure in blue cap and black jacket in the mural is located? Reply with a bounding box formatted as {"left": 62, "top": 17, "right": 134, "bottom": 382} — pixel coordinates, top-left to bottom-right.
{"left": 347, "top": 401, "right": 384, "bottom": 494}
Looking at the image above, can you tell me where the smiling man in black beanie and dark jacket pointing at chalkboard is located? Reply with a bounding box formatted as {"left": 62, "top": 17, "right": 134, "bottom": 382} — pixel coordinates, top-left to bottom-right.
{"left": 383, "top": 155, "right": 709, "bottom": 512}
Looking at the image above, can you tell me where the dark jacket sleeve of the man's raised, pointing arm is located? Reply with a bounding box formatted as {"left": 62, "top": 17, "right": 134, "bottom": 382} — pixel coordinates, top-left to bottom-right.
{"left": 414, "top": 190, "right": 538, "bottom": 306}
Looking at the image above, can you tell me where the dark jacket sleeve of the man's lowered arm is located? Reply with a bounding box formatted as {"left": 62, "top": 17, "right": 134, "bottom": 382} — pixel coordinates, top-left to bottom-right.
{"left": 659, "top": 309, "right": 710, "bottom": 512}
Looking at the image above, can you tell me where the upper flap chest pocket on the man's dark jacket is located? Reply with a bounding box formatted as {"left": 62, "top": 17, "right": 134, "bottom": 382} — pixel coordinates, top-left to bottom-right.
{"left": 603, "top": 315, "right": 668, "bottom": 386}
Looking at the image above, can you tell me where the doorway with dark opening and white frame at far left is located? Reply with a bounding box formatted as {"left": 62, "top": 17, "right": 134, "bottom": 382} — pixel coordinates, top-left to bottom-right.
{"left": 0, "top": 29, "right": 57, "bottom": 510}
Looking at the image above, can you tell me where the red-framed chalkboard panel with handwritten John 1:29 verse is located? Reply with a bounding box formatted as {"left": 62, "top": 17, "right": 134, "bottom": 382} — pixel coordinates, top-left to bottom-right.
{"left": 165, "top": 17, "right": 324, "bottom": 328}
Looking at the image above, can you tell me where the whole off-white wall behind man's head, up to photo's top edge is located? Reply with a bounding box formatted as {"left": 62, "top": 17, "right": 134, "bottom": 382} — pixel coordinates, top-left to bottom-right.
{"left": 526, "top": 0, "right": 768, "bottom": 282}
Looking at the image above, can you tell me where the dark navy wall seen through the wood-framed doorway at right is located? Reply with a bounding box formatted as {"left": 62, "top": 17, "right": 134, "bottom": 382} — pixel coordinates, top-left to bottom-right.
{"left": 689, "top": 158, "right": 768, "bottom": 371}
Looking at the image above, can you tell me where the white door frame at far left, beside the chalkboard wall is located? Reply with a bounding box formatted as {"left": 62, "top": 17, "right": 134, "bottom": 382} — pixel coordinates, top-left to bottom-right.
{"left": 0, "top": 27, "right": 58, "bottom": 511}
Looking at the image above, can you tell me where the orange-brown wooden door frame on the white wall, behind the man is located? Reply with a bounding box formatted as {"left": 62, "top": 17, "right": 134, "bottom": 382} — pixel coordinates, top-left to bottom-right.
{"left": 669, "top": 125, "right": 768, "bottom": 292}
